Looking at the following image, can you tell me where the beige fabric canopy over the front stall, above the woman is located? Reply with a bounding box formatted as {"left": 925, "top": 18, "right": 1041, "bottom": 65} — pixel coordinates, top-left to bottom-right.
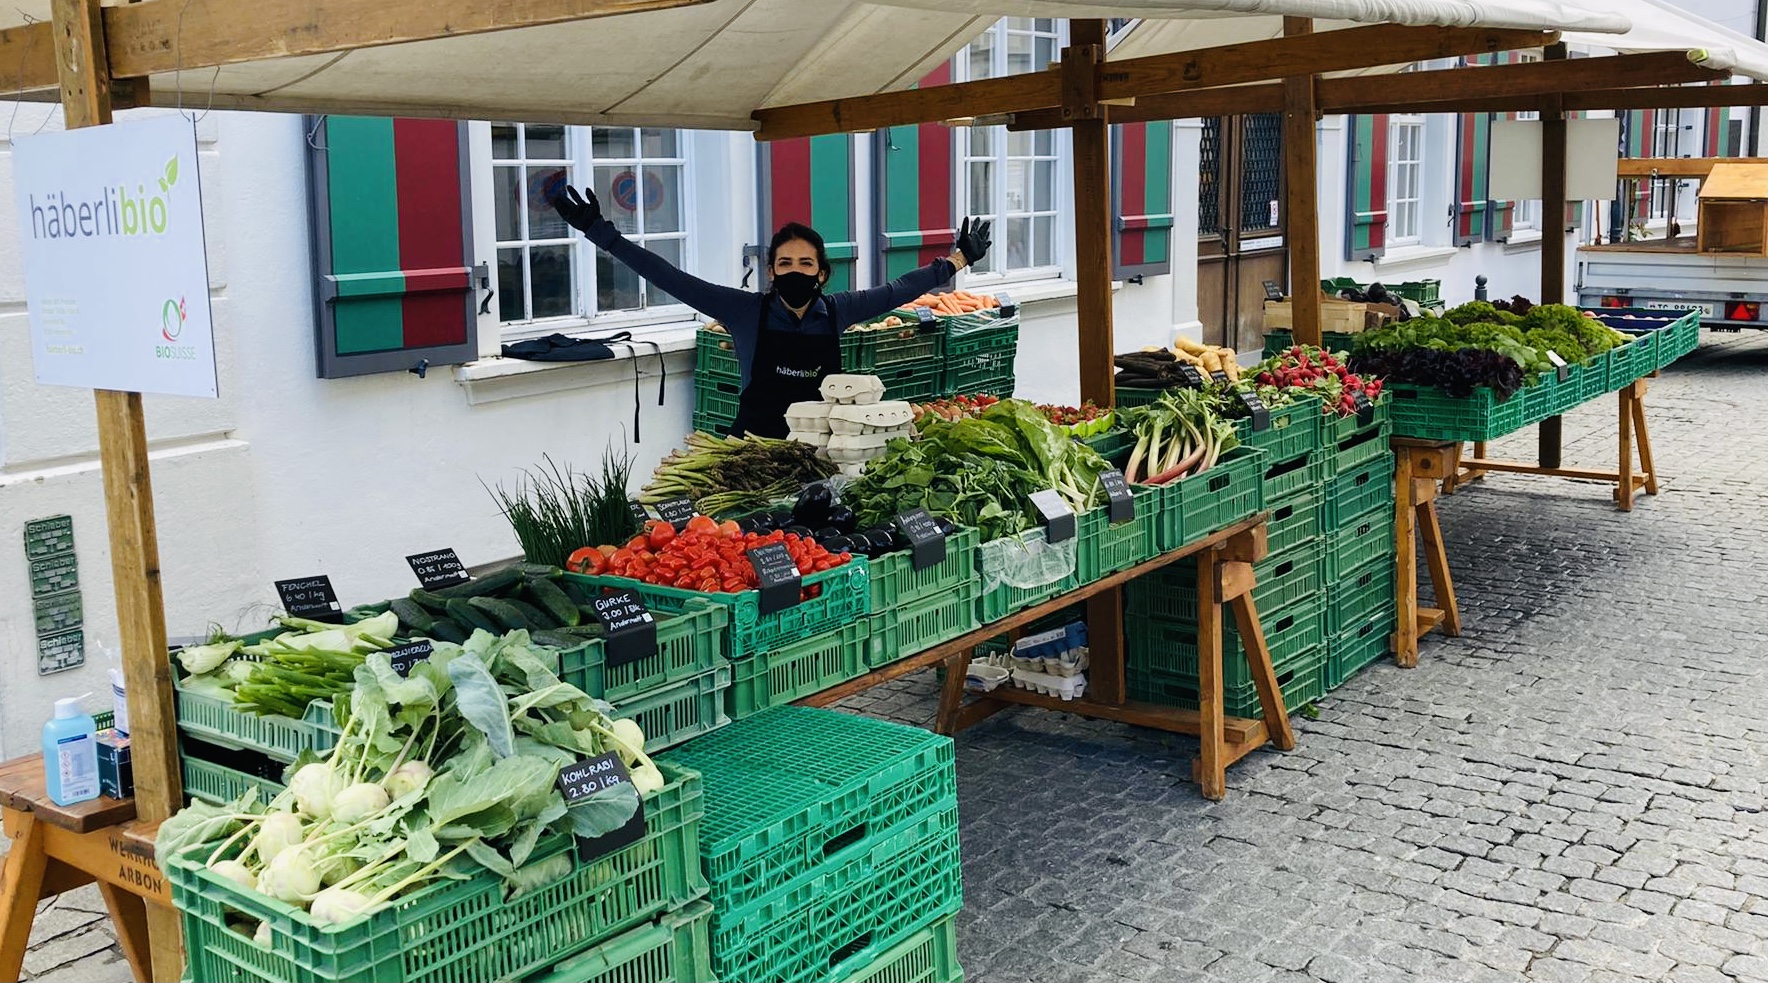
{"left": 0, "top": 0, "right": 1642, "bottom": 129}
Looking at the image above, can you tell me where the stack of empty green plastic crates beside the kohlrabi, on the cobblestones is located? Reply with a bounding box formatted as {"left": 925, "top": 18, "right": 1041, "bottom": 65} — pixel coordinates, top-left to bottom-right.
{"left": 667, "top": 707, "right": 964, "bottom": 983}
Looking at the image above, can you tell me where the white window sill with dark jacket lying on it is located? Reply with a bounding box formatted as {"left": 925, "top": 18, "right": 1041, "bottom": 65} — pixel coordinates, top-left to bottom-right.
{"left": 454, "top": 322, "right": 700, "bottom": 407}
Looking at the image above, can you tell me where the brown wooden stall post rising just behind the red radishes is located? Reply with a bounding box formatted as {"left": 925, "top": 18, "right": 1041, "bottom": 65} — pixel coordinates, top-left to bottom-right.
{"left": 1284, "top": 18, "right": 1321, "bottom": 345}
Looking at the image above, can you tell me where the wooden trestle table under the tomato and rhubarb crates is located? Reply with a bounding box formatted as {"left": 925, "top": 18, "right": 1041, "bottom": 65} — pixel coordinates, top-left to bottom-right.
{"left": 797, "top": 514, "right": 1296, "bottom": 799}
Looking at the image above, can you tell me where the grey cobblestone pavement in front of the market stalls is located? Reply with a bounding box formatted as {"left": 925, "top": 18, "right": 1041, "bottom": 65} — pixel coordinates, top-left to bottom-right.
{"left": 25, "top": 332, "right": 1768, "bottom": 983}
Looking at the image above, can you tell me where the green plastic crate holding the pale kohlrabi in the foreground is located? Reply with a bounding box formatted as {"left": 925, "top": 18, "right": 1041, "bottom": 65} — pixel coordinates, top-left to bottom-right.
{"left": 163, "top": 764, "right": 705, "bottom": 983}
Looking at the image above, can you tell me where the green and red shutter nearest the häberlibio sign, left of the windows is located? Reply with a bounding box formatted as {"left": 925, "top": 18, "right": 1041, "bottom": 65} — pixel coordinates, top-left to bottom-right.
{"left": 308, "top": 117, "right": 479, "bottom": 378}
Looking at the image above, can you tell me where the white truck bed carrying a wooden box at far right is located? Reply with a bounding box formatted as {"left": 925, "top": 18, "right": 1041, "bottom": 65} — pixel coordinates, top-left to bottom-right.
{"left": 1574, "top": 157, "right": 1768, "bottom": 331}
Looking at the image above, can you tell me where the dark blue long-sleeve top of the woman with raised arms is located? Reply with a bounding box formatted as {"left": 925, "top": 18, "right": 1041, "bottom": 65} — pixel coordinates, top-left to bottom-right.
{"left": 587, "top": 219, "right": 958, "bottom": 387}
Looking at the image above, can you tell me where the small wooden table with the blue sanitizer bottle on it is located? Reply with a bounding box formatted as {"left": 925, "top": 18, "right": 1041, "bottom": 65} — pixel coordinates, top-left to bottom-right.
{"left": 0, "top": 755, "right": 171, "bottom": 981}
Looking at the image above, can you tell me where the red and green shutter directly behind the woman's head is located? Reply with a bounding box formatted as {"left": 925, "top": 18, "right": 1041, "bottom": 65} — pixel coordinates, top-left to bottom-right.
{"left": 760, "top": 134, "right": 859, "bottom": 290}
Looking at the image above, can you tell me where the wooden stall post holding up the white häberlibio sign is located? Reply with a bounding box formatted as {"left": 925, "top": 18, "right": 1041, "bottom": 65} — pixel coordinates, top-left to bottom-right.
{"left": 51, "top": 0, "right": 184, "bottom": 979}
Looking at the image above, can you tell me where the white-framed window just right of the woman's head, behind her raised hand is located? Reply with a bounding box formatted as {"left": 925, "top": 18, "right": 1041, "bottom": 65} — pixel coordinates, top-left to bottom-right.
{"left": 956, "top": 18, "right": 1063, "bottom": 279}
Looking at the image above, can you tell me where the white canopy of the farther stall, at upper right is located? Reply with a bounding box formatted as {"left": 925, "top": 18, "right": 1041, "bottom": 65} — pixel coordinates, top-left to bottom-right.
{"left": 1110, "top": 0, "right": 1768, "bottom": 85}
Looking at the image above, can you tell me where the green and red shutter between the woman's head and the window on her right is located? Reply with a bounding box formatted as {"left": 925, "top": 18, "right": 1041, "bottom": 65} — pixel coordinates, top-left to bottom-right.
{"left": 875, "top": 62, "right": 954, "bottom": 281}
